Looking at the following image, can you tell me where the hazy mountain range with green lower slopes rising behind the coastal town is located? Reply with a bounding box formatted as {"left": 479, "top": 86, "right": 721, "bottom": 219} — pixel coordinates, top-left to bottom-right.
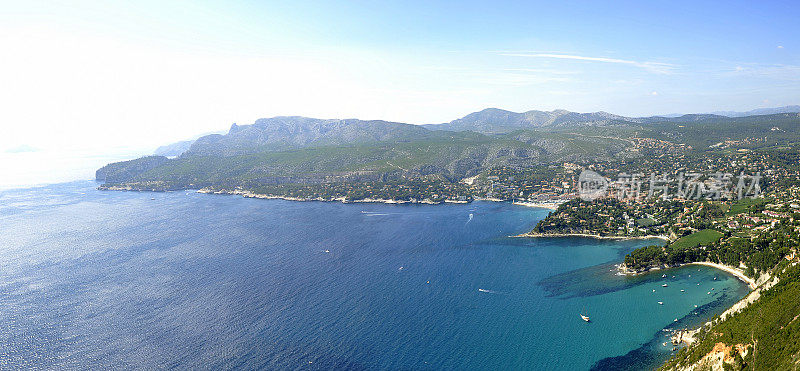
{"left": 97, "top": 108, "right": 800, "bottom": 189}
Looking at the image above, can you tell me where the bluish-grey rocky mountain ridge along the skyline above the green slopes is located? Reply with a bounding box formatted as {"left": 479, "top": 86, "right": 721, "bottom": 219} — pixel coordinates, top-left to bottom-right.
{"left": 155, "top": 106, "right": 800, "bottom": 157}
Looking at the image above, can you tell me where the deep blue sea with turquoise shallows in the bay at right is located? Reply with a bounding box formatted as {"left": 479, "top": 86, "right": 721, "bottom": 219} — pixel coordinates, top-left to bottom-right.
{"left": 0, "top": 182, "right": 747, "bottom": 370}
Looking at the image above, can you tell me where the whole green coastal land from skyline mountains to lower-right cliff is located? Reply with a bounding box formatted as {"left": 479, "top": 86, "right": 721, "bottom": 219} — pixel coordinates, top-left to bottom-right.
{"left": 92, "top": 109, "right": 800, "bottom": 369}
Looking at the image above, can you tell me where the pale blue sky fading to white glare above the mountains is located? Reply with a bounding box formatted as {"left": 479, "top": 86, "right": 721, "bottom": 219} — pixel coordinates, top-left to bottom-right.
{"left": 0, "top": 0, "right": 800, "bottom": 186}
